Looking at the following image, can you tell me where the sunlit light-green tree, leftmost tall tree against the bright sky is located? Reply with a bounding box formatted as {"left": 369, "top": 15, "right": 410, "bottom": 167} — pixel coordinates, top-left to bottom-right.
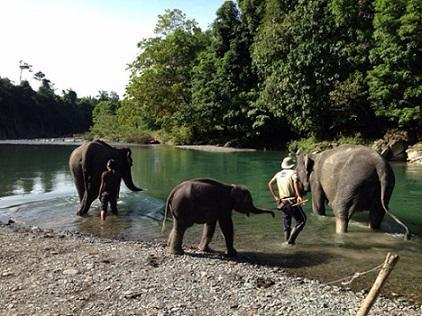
{"left": 123, "top": 10, "right": 207, "bottom": 142}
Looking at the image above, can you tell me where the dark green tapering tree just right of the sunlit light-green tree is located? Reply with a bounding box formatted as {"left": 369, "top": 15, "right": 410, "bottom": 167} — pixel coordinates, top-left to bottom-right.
{"left": 192, "top": 1, "right": 257, "bottom": 143}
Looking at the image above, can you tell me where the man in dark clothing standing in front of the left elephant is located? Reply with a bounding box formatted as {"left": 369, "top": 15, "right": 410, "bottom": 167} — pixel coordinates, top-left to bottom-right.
{"left": 98, "top": 159, "right": 122, "bottom": 221}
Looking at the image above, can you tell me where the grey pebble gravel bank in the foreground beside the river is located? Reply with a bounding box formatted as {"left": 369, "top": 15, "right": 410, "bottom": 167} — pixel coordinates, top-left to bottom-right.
{"left": 0, "top": 225, "right": 421, "bottom": 316}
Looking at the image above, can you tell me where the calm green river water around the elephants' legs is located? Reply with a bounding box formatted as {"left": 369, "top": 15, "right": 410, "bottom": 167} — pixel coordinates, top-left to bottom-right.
{"left": 0, "top": 144, "right": 422, "bottom": 304}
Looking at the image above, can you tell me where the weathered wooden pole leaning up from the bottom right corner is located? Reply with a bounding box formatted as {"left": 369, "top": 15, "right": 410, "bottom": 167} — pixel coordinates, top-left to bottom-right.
{"left": 356, "top": 253, "right": 400, "bottom": 316}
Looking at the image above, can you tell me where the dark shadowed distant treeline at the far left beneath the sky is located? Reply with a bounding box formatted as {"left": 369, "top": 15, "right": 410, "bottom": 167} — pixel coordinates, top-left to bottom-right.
{"left": 0, "top": 77, "right": 96, "bottom": 139}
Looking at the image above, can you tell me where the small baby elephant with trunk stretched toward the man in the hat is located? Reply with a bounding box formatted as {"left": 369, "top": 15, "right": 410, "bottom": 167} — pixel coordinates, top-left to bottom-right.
{"left": 164, "top": 179, "right": 274, "bottom": 257}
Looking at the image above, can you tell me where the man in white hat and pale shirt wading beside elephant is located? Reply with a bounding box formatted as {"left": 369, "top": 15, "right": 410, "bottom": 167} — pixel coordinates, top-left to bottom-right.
{"left": 268, "top": 157, "right": 306, "bottom": 245}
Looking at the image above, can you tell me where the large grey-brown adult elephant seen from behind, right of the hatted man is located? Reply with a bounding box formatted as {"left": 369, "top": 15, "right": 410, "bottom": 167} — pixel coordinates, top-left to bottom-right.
{"left": 296, "top": 145, "right": 410, "bottom": 239}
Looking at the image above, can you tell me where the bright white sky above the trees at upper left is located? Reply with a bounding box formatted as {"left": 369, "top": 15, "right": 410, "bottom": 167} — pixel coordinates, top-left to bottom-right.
{"left": 0, "top": 0, "right": 224, "bottom": 97}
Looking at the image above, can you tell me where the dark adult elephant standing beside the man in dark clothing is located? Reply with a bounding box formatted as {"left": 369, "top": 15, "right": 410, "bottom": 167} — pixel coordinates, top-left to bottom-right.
{"left": 69, "top": 140, "right": 142, "bottom": 216}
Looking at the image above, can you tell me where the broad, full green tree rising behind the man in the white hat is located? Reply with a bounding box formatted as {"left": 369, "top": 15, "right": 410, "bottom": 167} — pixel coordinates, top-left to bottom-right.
{"left": 253, "top": 0, "right": 341, "bottom": 137}
